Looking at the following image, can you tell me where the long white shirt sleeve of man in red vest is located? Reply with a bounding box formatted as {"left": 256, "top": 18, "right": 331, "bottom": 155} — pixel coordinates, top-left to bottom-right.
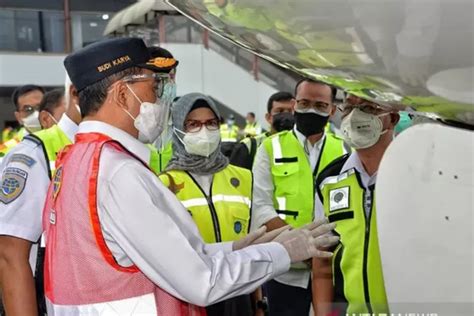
{"left": 98, "top": 155, "right": 290, "bottom": 306}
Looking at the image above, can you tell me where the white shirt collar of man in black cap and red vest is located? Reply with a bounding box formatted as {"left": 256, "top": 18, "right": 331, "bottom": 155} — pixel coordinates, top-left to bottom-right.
{"left": 77, "top": 121, "right": 150, "bottom": 164}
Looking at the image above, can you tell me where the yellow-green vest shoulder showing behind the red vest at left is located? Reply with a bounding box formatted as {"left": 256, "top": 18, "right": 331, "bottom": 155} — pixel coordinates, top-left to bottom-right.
{"left": 24, "top": 125, "right": 72, "bottom": 179}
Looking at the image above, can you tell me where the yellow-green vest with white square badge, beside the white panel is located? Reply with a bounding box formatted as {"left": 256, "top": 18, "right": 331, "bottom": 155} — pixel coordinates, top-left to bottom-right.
{"left": 320, "top": 169, "right": 388, "bottom": 315}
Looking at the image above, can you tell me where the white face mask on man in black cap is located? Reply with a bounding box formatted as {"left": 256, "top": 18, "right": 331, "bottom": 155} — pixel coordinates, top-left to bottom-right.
{"left": 123, "top": 85, "right": 169, "bottom": 144}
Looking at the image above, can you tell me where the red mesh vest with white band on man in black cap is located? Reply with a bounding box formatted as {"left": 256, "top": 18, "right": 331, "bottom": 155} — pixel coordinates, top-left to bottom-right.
{"left": 43, "top": 133, "right": 205, "bottom": 316}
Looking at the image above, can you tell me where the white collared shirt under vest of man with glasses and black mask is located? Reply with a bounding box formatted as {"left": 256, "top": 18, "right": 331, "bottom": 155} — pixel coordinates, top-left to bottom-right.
{"left": 251, "top": 127, "right": 326, "bottom": 288}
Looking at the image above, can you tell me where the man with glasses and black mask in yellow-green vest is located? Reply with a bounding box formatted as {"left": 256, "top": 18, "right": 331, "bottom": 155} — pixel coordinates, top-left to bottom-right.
{"left": 251, "top": 79, "right": 347, "bottom": 316}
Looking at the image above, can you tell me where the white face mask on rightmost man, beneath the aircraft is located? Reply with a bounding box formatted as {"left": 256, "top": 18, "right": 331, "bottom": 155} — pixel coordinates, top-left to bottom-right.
{"left": 341, "top": 108, "right": 390, "bottom": 149}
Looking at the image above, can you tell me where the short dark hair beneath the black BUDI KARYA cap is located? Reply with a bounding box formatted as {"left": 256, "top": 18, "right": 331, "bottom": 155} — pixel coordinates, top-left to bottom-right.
{"left": 78, "top": 67, "right": 142, "bottom": 117}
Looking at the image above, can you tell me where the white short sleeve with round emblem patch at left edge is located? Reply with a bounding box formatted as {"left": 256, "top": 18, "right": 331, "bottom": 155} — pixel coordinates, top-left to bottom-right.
{"left": 0, "top": 140, "right": 50, "bottom": 242}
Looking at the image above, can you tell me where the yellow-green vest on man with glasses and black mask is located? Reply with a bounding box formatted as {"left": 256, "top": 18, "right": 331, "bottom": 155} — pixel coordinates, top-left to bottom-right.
{"left": 262, "top": 131, "right": 346, "bottom": 227}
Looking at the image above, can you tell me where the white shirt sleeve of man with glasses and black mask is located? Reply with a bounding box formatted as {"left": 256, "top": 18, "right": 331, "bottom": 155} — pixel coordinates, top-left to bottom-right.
{"left": 250, "top": 146, "right": 278, "bottom": 231}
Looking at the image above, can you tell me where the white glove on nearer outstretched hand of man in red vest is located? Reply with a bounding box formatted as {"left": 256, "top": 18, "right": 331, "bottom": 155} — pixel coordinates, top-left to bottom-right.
{"left": 273, "top": 220, "right": 339, "bottom": 263}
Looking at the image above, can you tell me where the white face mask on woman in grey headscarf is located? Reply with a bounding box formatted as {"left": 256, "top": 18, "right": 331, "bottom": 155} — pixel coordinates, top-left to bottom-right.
{"left": 174, "top": 126, "right": 221, "bottom": 157}
